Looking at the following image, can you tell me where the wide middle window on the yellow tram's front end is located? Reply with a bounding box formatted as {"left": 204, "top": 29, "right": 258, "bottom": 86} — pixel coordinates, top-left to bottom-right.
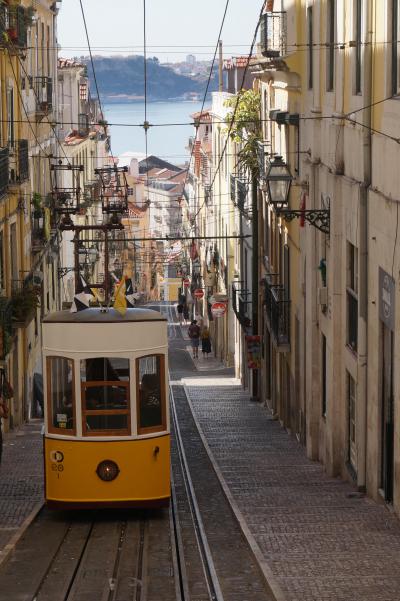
{"left": 81, "top": 357, "right": 130, "bottom": 436}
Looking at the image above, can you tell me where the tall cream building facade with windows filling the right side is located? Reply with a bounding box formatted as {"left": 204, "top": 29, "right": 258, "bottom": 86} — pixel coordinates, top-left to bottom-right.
{"left": 253, "top": 0, "right": 400, "bottom": 512}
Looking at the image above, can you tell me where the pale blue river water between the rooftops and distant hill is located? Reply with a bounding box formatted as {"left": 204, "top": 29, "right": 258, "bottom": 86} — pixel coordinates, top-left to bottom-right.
{"left": 103, "top": 101, "right": 205, "bottom": 164}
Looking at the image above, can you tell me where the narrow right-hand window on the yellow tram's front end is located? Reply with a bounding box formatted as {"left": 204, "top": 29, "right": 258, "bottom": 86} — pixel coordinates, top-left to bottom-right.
{"left": 136, "top": 355, "right": 166, "bottom": 432}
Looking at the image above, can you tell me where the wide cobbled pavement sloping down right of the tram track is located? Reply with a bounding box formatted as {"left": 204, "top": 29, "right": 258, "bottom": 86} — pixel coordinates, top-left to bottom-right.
{"left": 186, "top": 377, "right": 400, "bottom": 601}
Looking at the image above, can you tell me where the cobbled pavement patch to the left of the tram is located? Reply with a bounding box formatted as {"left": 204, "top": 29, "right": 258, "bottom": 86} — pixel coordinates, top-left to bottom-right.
{"left": 0, "top": 420, "right": 43, "bottom": 558}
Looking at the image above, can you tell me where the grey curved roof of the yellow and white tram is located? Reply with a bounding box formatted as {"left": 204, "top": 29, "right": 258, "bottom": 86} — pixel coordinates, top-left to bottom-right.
{"left": 43, "top": 307, "right": 167, "bottom": 323}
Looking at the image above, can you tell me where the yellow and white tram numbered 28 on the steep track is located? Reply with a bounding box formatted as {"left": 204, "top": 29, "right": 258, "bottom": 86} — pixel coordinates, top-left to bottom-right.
{"left": 42, "top": 308, "right": 170, "bottom": 508}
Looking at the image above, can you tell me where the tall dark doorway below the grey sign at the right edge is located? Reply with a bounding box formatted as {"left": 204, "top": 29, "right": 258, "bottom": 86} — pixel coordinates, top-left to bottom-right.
{"left": 381, "top": 323, "right": 394, "bottom": 503}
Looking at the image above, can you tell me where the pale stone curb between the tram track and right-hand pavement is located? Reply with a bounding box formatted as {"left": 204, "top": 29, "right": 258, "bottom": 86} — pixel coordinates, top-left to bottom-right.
{"left": 182, "top": 378, "right": 287, "bottom": 601}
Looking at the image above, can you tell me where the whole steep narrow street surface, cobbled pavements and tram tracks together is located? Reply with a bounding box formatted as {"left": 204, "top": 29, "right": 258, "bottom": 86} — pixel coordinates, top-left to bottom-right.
{"left": 0, "top": 304, "right": 400, "bottom": 601}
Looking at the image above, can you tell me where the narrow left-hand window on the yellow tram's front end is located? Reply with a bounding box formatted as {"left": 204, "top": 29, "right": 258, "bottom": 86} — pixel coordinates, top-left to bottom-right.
{"left": 47, "top": 357, "right": 75, "bottom": 434}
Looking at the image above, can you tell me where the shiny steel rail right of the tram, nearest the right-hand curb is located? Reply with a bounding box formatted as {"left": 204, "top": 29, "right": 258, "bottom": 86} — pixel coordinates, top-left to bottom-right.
{"left": 170, "top": 388, "right": 224, "bottom": 601}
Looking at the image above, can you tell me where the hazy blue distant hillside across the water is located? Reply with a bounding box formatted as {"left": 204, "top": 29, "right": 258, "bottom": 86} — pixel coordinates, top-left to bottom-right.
{"left": 80, "top": 56, "right": 217, "bottom": 101}
